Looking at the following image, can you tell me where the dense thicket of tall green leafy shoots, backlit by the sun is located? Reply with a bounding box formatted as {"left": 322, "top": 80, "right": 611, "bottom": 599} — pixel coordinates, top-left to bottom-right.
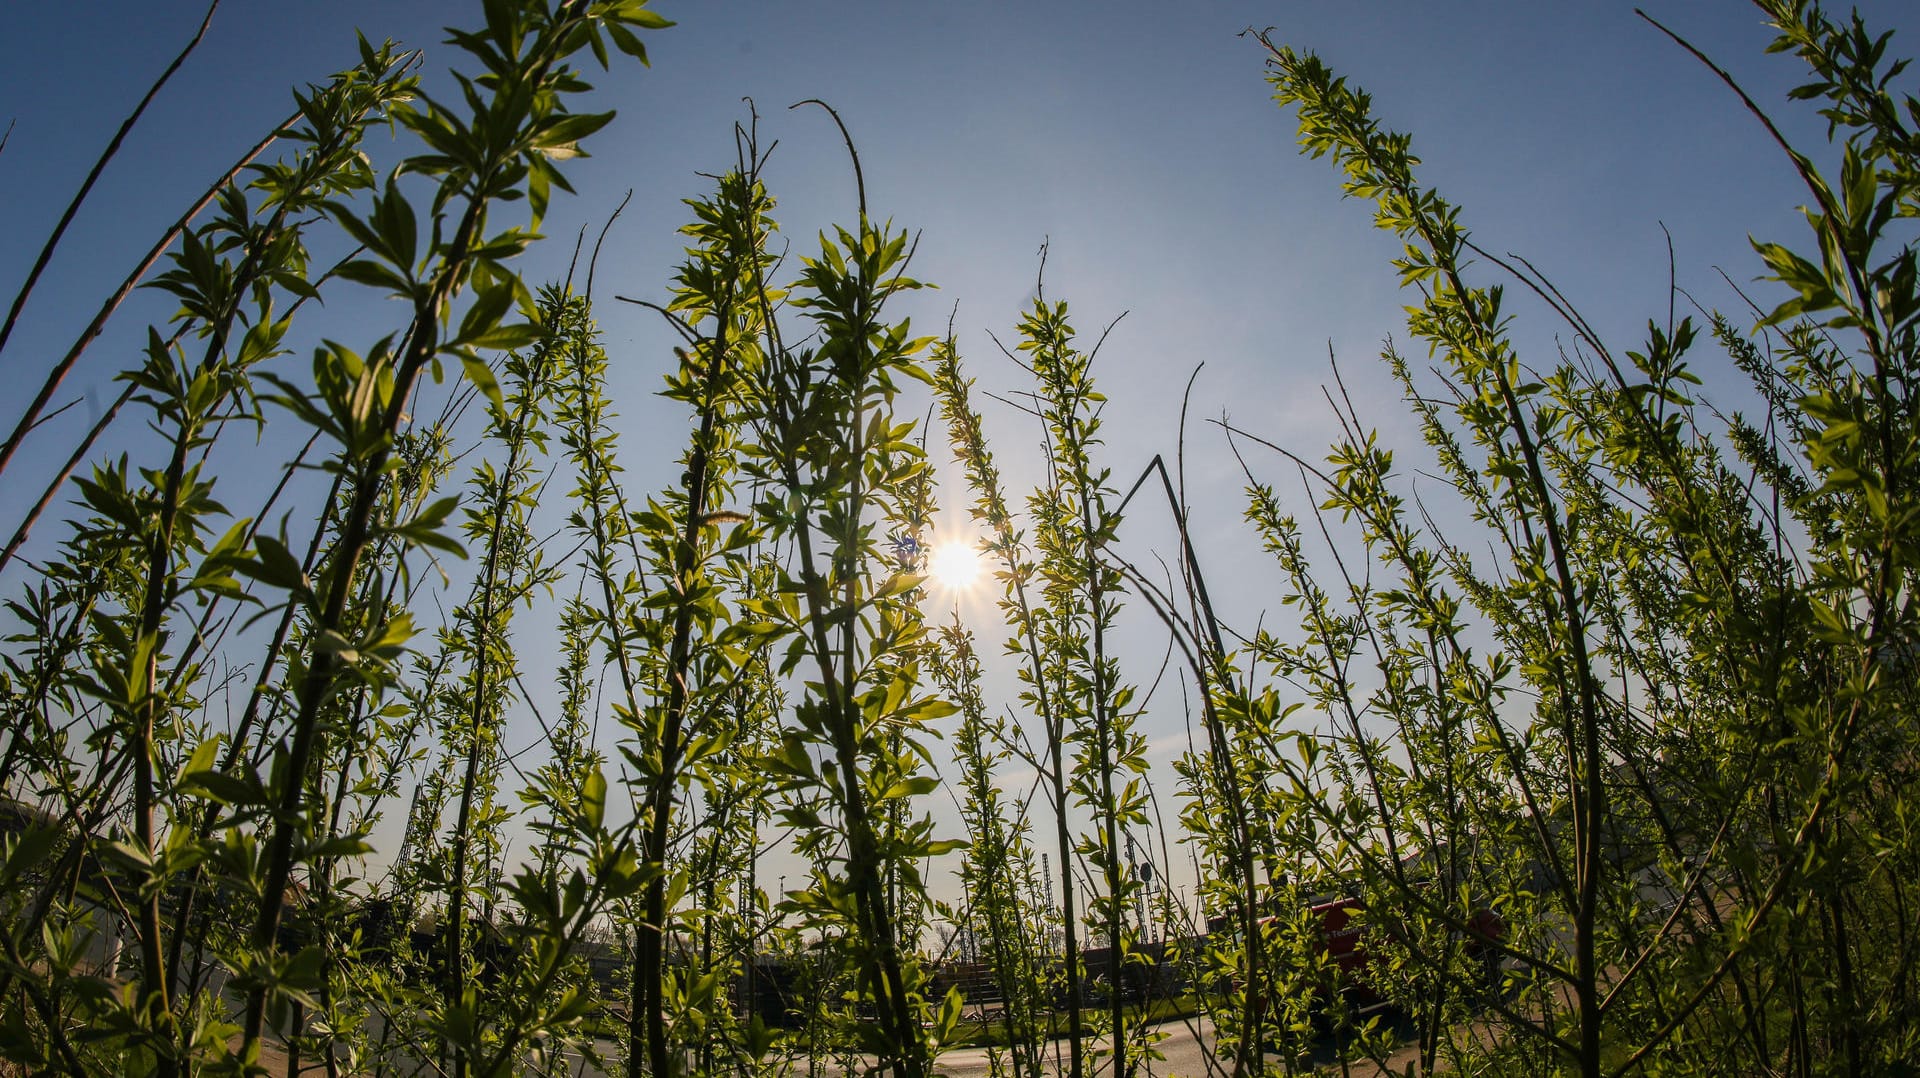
{"left": 0, "top": 0, "right": 1920, "bottom": 1078}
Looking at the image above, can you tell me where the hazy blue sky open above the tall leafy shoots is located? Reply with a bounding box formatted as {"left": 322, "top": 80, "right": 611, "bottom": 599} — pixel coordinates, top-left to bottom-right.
{"left": 0, "top": 0, "right": 1920, "bottom": 914}
